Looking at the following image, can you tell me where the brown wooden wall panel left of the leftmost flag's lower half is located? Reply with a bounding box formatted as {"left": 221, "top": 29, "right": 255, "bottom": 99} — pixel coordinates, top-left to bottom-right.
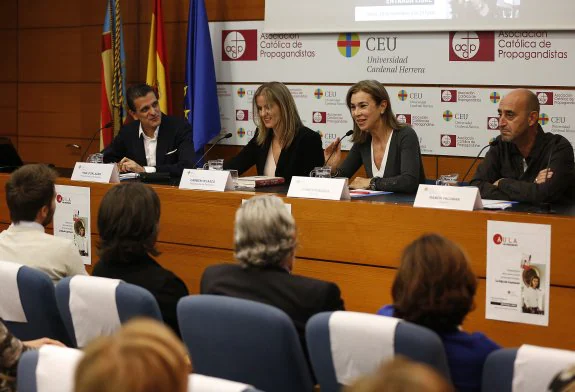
{"left": 18, "top": 83, "right": 100, "bottom": 139}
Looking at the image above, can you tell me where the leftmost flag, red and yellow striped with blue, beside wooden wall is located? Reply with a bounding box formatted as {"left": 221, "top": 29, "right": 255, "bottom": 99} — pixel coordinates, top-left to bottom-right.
{"left": 100, "top": 0, "right": 128, "bottom": 149}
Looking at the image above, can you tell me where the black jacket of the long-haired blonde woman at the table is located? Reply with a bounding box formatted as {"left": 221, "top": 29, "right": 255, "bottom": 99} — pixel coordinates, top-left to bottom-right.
{"left": 224, "top": 127, "right": 323, "bottom": 182}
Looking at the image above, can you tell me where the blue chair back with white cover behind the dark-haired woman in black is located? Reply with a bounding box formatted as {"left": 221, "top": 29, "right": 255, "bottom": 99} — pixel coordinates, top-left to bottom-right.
{"left": 56, "top": 276, "right": 163, "bottom": 347}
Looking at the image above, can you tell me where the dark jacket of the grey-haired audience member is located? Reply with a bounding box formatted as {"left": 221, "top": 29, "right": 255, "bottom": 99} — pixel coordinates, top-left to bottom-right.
{"left": 200, "top": 264, "right": 344, "bottom": 352}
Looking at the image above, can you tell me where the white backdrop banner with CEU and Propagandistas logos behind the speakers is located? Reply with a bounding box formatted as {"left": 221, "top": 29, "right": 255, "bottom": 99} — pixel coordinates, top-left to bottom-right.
{"left": 210, "top": 22, "right": 575, "bottom": 157}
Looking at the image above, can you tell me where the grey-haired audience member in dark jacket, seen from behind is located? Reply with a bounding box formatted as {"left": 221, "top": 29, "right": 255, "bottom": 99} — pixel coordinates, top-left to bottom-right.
{"left": 200, "top": 195, "right": 344, "bottom": 364}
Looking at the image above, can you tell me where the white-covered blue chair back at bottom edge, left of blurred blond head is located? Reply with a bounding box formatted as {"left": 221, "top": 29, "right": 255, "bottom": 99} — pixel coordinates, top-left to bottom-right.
{"left": 17, "top": 345, "right": 83, "bottom": 392}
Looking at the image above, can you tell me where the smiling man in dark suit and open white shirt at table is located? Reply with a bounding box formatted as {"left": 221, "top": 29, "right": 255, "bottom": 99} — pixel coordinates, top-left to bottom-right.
{"left": 104, "top": 84, "right": 195, "bottom": 176}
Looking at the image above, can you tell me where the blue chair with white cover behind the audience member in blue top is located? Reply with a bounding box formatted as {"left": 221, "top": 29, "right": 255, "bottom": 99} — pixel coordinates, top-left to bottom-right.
{"left": 306, "top": 311, "right": 450, "bottom": 392}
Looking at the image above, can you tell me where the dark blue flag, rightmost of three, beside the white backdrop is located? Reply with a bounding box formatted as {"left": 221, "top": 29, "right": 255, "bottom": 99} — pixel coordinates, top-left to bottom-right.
{"left": 184, "top": 0, "right": 221, "bottom": 155}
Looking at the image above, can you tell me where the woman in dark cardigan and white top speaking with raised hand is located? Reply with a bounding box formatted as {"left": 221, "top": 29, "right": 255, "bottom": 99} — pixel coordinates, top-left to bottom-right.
{"left": 324, "top": 80, "right": 425, "bottom": 193}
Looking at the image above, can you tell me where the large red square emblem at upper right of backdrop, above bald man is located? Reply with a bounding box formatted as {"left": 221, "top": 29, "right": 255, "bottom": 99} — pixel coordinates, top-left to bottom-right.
{"left": 449, "top": 31, "right": 495, "bottom": 61}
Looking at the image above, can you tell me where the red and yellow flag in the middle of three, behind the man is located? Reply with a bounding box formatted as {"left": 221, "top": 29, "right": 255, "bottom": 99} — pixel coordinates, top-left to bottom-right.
{"left": 146, "top": 0, "right": 172, "bottom": 114}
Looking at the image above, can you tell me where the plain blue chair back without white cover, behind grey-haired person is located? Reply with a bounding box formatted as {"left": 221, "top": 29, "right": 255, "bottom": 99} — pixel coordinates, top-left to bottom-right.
{"left": 178, "top": 295, "right": 313, "bottom": 392}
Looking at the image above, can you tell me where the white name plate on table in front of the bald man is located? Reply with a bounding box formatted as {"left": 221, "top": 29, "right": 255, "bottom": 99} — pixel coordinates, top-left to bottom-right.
{"left": 413, "top": 184, "right": 483, "bottom": 211}
